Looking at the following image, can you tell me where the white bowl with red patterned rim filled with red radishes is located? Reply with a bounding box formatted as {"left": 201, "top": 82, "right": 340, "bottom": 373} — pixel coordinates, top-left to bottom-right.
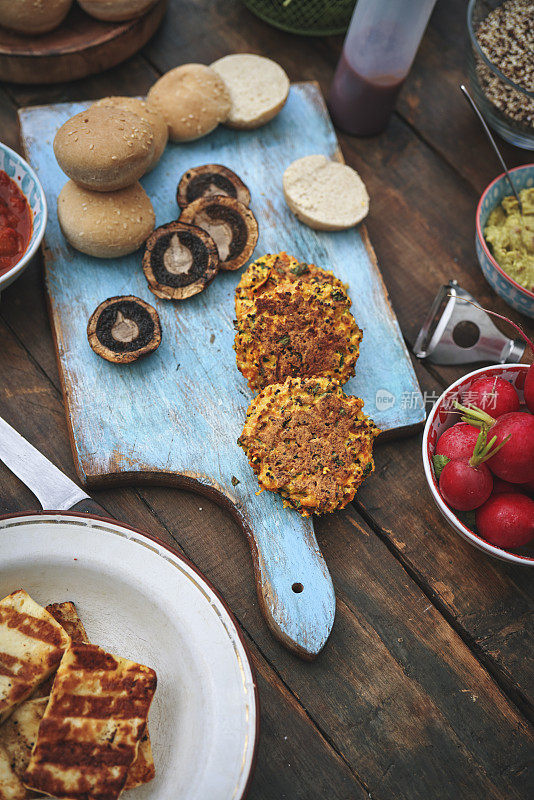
{"left": 423, "top": 364, "right": 534, "bottom": 566}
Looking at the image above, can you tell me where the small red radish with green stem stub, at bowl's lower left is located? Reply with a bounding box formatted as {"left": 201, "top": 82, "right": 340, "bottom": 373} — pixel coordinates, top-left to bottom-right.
{"left": 439, "top": 428, "right": 498, "bottom": 511}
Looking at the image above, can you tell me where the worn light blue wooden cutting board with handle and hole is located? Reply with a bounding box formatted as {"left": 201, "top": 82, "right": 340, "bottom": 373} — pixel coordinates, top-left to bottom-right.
{"left": 20, "top": 83, "right": 424, "bottom": 658}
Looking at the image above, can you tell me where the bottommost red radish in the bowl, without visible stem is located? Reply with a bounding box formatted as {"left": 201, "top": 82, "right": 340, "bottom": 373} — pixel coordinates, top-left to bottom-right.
{"left": 478, "top": 494, "right": 534, "bottom": 548}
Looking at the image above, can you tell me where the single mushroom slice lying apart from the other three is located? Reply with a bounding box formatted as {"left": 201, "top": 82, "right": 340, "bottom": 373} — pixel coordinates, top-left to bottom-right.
{"left": 87, "top": 295, "right": 161, "bottom": 364}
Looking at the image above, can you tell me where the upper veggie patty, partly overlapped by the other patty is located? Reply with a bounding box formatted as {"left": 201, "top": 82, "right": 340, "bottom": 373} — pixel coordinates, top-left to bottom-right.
{"left": 234, "top": 281, "right": 363, "bottom": 391}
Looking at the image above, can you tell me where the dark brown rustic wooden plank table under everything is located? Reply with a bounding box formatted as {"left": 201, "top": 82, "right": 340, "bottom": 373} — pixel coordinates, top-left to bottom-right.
{"left": 0, "top": 0, "right": 534, "bottom": 800}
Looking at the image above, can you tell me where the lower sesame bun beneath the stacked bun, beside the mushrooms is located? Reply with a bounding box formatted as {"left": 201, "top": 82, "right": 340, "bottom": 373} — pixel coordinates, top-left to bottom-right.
{"left": 57, "top": 181, "right": 156, "bottom": 258}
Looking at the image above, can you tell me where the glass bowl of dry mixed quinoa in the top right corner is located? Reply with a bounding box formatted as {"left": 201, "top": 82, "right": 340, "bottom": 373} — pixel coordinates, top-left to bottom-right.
{"left": 467, "top": 0, "right": 534, "bottom": 150}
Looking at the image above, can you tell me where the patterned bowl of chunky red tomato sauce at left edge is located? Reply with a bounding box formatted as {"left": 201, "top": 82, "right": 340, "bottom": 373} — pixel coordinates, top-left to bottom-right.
{"left": 0, "top": 142, "right": 47, "bottom": 293}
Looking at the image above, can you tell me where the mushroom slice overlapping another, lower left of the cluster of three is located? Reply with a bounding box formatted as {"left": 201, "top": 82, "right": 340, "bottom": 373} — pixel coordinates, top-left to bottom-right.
{"left": 143, "top": 221, "right": 219, "bottom": 300}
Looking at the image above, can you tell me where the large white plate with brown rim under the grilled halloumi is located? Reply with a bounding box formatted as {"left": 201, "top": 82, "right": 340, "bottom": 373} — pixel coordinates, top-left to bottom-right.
{"left": 0, "top": 513, "right": 258, "bottom": 800}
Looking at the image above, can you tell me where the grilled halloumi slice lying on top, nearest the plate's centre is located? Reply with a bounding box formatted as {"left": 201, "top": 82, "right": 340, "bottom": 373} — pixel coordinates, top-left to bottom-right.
{"left": 24, "top": 643, "right": 157, "bottom": 800}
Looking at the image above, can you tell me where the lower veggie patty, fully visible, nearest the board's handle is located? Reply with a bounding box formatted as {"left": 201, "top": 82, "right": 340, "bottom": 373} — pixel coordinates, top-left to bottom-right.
{"left": 238, "top": 378, "right": 380, "bottom": 517}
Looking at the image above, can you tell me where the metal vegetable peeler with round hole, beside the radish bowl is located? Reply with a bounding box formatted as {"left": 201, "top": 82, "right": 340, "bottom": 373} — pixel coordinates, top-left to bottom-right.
{"left": 414, "top": 280, "right": 526, "bottom": 364}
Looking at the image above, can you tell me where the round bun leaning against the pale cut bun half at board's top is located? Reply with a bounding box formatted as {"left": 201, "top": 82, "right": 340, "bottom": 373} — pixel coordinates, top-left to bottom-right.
{"left": 147, "top": 64, "right": 230, "bottom": 142}
